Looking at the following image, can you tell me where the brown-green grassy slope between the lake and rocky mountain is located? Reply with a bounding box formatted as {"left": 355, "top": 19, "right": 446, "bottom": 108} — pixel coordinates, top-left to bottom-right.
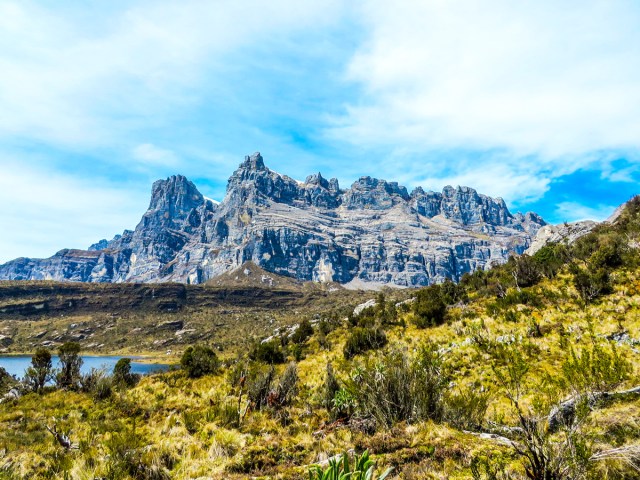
{"left": 0, "top": 264, "right": 384, "bottom": 361}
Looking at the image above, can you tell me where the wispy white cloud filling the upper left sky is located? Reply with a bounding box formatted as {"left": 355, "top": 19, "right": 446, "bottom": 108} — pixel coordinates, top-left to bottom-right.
{"left": 0, "top": 0, "right": 348, "bottom": 148}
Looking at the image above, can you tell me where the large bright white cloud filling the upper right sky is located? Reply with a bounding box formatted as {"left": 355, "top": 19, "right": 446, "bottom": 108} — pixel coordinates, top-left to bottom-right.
{"left": 330, "top": 0, "right": 640, "bottom": 196}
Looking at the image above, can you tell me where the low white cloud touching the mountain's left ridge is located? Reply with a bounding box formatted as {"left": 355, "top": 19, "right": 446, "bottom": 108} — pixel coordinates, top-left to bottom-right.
{"left": 0, "top": 163, "right": 149, "bottom": 263}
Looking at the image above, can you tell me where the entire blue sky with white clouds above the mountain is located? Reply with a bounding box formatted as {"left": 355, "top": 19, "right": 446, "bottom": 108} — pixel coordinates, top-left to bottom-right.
{"left": 0, "top": 0, "right": 640, "bottom": 263}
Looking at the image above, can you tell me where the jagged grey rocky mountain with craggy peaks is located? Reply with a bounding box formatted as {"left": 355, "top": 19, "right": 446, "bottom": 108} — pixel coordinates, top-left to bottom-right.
{"left": 0, "top": 153, "right": 545, "bottom": 288}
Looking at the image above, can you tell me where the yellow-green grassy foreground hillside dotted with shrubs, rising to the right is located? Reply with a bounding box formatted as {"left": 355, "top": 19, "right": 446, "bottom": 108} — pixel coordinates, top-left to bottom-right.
{"left": 0, "top": 200, "right": 640, "bottom": 479}
